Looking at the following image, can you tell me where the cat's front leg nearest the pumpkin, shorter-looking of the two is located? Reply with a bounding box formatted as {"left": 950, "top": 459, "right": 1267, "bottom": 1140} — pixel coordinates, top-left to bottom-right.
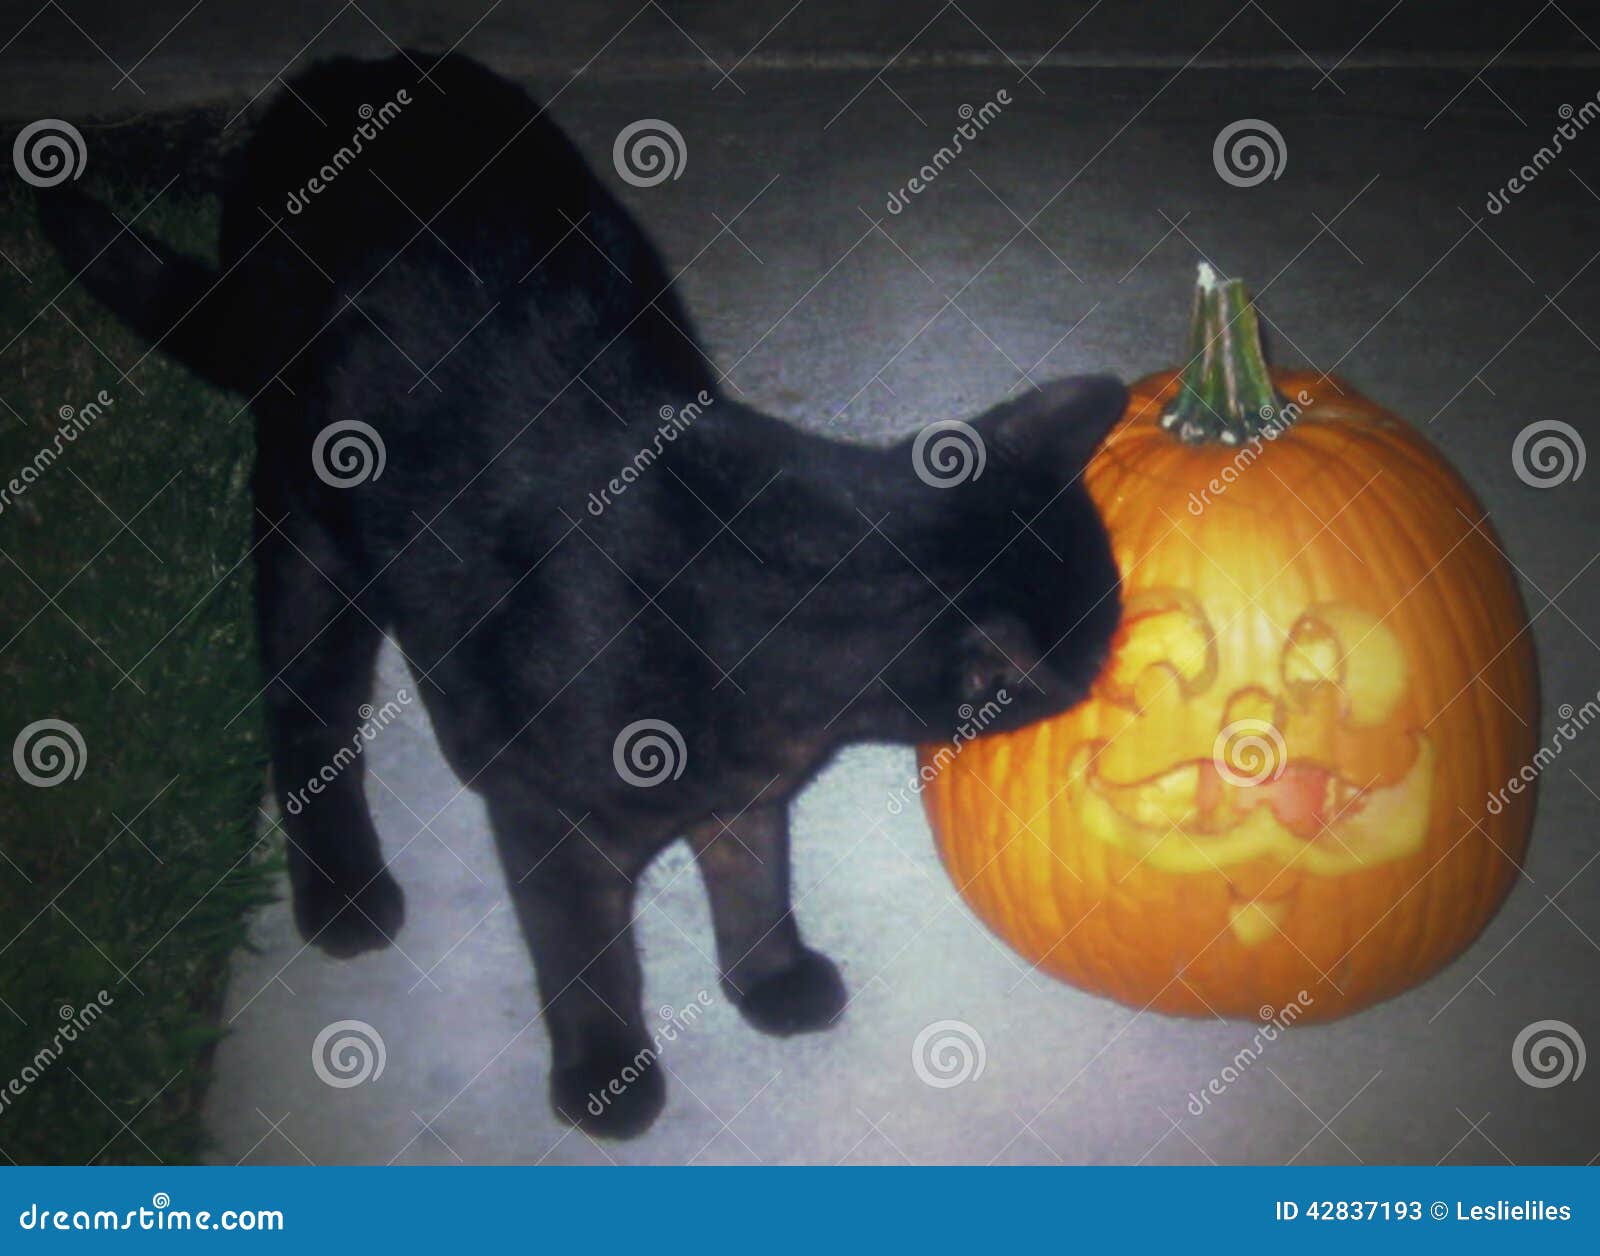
{"left": 690, "top": 803, "right": 848, "bottom": 1034}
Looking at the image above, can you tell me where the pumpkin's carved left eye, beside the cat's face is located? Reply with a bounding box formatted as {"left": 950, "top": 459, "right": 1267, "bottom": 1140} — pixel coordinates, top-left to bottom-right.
{"left": 1099, "top": 589, "right": 1216, "bottom": 710}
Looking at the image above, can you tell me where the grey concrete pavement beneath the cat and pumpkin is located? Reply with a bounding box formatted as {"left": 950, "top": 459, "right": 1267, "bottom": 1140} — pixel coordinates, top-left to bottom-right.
{"left": 15, "top": 6, "right": 1600, "bottom": 1163}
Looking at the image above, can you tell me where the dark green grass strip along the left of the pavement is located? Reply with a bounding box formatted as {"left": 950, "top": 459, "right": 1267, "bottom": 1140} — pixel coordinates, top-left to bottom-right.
{"left": 0, "top": 170, "right": 275, "bottom": 1163}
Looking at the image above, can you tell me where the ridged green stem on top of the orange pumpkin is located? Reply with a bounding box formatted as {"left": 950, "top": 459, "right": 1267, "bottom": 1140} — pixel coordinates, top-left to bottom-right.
{"left": 1162, "top": 262, "right": 1283, "bottom": 445}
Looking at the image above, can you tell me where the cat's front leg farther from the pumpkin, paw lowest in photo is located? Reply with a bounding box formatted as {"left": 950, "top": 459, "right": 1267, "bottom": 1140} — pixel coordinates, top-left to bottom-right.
{"left": 486, "top": 790, "right": 666, "bottom": 1138}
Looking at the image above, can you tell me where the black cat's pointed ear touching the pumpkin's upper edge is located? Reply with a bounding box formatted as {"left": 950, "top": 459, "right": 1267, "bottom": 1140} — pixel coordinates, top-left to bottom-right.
{"left": 976, "top": 374, "right": 1128, "bottom": 475}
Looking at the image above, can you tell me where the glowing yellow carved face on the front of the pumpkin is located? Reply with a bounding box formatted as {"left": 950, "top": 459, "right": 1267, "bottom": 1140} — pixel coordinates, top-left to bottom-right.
{"left": 1066, "top": 589, "right": 1435, "bottom": 889}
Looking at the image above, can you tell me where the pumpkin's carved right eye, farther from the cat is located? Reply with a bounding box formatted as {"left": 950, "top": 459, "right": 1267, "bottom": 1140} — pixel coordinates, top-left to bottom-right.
{"left": 1282, "top": 602, "right": 1406, "bottom": 728}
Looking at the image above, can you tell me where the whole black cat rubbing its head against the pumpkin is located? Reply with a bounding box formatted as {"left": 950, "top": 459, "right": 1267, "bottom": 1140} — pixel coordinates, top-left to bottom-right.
{"left": 42, "top": 56, "right": 1125, "bottom": 1136}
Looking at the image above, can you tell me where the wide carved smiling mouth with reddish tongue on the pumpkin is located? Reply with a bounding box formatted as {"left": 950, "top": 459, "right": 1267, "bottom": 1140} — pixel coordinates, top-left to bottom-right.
{"left": 1067, "top": 733, "right": 1435, "bottom": 875}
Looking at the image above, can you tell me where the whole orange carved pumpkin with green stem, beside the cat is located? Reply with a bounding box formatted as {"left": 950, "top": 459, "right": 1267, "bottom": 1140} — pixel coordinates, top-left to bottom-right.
{"left": 922, "top": 267, "right": 1538, "bottom": 1019}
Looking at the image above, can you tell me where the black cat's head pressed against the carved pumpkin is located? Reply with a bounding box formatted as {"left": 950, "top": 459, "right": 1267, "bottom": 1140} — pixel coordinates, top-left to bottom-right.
{"left": 885, "top": 374, "right": 1128, "bottom": 739}
